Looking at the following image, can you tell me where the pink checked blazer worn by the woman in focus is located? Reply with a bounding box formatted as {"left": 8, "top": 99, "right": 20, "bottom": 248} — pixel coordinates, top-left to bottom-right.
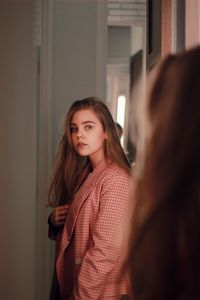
{"left": 49, "top": 161, "right": 130, "bottom": 300}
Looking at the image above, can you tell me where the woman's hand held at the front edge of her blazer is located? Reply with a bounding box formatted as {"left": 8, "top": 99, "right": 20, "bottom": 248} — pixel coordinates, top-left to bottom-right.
{"left": 50, "top": 204, "right": 70, "bottom": 228}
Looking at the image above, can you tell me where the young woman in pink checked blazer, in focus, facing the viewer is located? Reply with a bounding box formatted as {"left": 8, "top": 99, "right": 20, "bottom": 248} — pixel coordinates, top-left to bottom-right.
{"left": 49, "top": 97, "right": 131, "bottom": 300}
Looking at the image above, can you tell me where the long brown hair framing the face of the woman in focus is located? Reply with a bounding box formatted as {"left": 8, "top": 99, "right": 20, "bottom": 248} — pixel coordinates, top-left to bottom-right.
{"left": 49, "top": 97, "right": 131, "bottom": 206}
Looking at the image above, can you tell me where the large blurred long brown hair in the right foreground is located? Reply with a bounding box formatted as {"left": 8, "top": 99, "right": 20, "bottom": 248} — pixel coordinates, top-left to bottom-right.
{"left": 128, "top": 47, "right": 200, "bottom": 300}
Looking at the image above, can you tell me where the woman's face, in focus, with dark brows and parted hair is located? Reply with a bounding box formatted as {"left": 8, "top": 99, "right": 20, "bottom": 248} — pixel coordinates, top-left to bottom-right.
{"left": 70, "top": 109, "right": 107, "bottom": 168}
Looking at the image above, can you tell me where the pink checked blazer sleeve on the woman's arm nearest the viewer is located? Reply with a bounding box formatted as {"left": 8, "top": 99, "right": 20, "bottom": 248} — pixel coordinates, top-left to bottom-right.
{"left": 72, "top": 173, "right": 130, "bottom": 300}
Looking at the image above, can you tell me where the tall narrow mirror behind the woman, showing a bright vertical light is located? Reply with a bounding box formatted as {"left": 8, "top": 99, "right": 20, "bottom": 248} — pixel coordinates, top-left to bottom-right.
{"left": 106, "top": 0, "right": 146, "bottom": 162}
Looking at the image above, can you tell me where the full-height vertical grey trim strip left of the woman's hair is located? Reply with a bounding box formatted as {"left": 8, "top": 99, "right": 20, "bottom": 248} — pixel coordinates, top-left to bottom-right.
{"left": 36, "top": 0, "right": 53, "bottom": 300}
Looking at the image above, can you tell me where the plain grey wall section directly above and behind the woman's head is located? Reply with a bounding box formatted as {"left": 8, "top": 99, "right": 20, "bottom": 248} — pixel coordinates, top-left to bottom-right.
{"left": 52, "top": 0, "right": 107, "bottom": 147}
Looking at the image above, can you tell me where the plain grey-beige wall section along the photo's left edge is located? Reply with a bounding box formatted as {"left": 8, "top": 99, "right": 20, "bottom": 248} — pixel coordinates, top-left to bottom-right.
{"left": 0, "top": 0, "right": 37, "bottom": 300}
